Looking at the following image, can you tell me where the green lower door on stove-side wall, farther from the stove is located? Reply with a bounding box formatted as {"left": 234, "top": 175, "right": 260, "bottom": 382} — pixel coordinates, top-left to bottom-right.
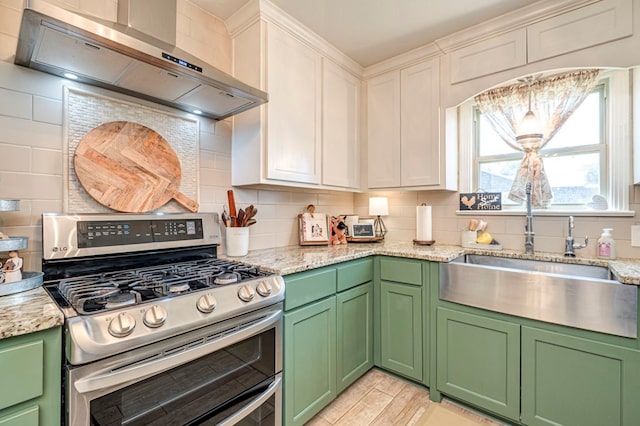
{"left": 336, "top": 282, "right": 373, "bottom": 393}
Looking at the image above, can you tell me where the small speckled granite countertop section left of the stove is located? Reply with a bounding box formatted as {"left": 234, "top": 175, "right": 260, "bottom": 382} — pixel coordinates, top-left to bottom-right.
{"left": 0, "top": 284, "right": 64, "bottom": 339}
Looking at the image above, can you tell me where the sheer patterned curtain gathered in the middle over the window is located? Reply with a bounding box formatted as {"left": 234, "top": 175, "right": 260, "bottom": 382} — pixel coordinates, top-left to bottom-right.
{"left": 474, "top": 69, "right": 600, "bottom": 208}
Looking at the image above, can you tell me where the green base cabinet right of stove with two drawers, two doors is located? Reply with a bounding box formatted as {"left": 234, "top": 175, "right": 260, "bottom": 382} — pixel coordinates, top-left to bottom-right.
{"left": 283, "top": 258, "right": 373, "bottom": 425}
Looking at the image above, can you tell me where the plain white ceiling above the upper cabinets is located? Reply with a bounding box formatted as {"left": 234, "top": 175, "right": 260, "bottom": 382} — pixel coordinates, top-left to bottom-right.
{"left": 190, "top": 0, "right": 536, "bottom": 67}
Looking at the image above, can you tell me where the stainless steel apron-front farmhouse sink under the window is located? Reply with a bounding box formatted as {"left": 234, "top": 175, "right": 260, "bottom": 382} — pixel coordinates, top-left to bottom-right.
{"left": 440, "top": 255, "right": 638, "bottom": 338}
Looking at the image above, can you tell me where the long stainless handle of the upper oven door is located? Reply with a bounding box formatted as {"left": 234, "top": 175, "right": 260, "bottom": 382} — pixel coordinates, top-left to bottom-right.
{"left": 73, "top": 310, "right": 282, "bottom": 393}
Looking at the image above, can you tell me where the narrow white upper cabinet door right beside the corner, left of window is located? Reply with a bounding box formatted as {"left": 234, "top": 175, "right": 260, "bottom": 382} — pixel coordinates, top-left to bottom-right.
{"left": 367, "top": 71, "right": 400, "bottom": 188}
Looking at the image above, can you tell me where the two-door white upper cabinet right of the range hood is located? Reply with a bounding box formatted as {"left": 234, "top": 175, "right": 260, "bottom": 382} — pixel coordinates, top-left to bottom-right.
{"left": 227, "top": 1, "right": 362, "bottom": 190}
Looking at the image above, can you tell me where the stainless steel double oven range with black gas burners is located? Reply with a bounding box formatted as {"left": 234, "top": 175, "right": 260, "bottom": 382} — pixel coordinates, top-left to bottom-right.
{"left": 42, "top": 213, "right": 284, "bottom": 426}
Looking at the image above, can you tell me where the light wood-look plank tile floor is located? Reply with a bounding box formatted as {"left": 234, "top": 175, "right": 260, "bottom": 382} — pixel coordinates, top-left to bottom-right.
{"left": 307, "top": 368, "right": 502, "bottom": 426}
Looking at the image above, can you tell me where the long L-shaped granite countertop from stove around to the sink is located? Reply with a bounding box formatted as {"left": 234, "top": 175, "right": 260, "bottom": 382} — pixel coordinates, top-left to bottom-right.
{"left": 219, "top": 241, "right": 640, "bottom": 285}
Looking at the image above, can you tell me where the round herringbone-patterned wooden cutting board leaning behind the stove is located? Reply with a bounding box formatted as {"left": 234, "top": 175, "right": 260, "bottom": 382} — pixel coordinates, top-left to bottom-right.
{"left": 73, "top": 121, "right": 198, "bottom": 213}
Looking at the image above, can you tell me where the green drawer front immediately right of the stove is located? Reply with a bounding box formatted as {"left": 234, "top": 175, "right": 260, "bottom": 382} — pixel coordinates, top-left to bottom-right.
{"left": 284, "top": 268, "right": 336, "bottom": 311}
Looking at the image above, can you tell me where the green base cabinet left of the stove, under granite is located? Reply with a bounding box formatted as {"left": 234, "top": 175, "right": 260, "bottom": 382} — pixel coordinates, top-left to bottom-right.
{"left": 0, "top": 327, "right": 62, "bottom": 426}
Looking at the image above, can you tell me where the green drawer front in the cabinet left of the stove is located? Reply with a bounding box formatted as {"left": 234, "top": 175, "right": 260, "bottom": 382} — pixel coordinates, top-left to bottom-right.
{"left": 0, "top": 336, "right": 44, "bottom": 409}
